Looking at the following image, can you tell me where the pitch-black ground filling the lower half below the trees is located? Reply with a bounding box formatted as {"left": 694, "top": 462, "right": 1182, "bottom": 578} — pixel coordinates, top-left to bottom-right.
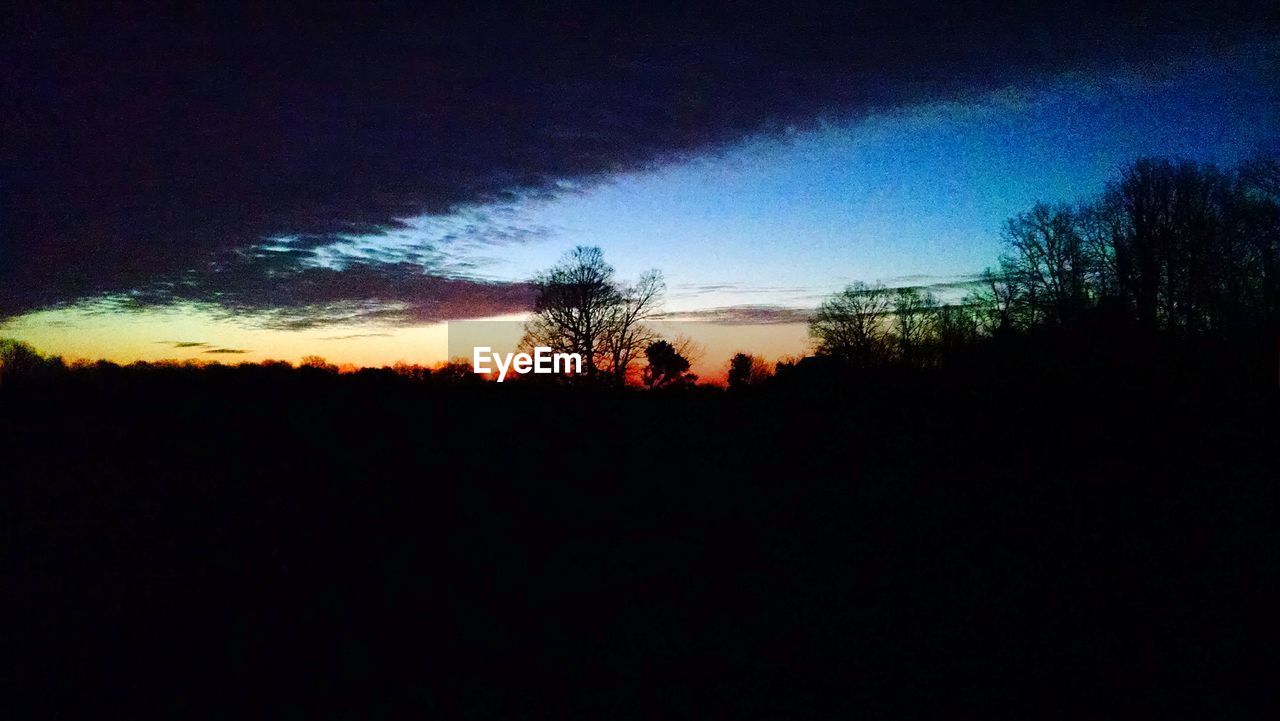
{"left": 0, "top": 363, "right": 1280, "bottom": 718}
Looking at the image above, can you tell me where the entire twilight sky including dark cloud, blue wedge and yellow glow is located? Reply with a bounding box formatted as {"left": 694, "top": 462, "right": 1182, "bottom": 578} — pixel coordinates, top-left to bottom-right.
{"left": 0, "top": 3, "right": 1280, "bottom": 374}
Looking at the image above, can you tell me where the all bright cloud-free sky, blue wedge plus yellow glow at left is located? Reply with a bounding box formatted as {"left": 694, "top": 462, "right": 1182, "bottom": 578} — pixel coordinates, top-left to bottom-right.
{"left": 0, "top": 45, "right": 1280, "bottom": 365}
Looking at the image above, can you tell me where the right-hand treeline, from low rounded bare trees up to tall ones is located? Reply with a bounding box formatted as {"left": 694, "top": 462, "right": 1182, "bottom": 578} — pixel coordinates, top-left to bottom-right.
{"left": 810, "top": 159, "right": 1280, "bottom": 381}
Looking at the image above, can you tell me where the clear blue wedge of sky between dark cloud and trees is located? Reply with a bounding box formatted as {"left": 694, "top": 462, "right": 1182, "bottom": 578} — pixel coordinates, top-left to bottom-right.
{"left": 399, "top": 42, "right": 1280, "bottom": 306}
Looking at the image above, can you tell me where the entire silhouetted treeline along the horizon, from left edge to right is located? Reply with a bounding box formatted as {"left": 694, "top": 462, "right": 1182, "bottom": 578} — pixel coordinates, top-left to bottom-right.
{"left": 0, "top": 153, "right": 1280, "bottom": 388}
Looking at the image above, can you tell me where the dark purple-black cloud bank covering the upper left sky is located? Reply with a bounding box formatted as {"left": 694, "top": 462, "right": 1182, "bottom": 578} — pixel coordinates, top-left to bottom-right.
{"left": 0, "top": 0, "right": 1280, "bottom": 325}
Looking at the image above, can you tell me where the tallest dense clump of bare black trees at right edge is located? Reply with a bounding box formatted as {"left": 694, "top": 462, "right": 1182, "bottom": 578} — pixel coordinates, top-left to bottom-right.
{"left": 969, "top": 158, "right": 1280, "bottom": 384}
